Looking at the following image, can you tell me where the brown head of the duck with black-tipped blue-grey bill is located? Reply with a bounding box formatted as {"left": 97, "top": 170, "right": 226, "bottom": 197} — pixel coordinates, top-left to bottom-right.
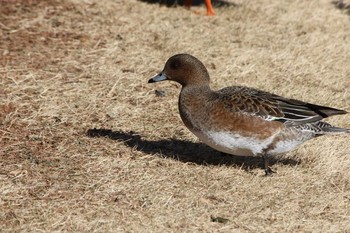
{"left": 148, "top": 54, "right": 210, "bottom": 87}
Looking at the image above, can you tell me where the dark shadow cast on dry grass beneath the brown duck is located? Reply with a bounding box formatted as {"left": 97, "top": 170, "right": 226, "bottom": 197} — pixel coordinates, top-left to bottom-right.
{"left": 87, "top": 128, "right": 299, "bottom": 170}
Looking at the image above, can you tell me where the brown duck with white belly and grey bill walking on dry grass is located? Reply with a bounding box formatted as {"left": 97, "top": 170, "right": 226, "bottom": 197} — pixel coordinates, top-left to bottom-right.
{"left": 148, "top": 54, "right": 350, "bottom": 176}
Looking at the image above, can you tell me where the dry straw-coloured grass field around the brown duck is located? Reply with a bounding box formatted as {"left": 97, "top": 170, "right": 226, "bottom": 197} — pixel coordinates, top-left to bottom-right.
{"left": 0, "top": 0, "right": 350, "bottom": 232}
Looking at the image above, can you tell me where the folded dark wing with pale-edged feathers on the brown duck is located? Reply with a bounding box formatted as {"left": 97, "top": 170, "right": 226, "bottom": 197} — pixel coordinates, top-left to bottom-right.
{"left": 217, "top": 87, "right": 347, "bottom": 125}
